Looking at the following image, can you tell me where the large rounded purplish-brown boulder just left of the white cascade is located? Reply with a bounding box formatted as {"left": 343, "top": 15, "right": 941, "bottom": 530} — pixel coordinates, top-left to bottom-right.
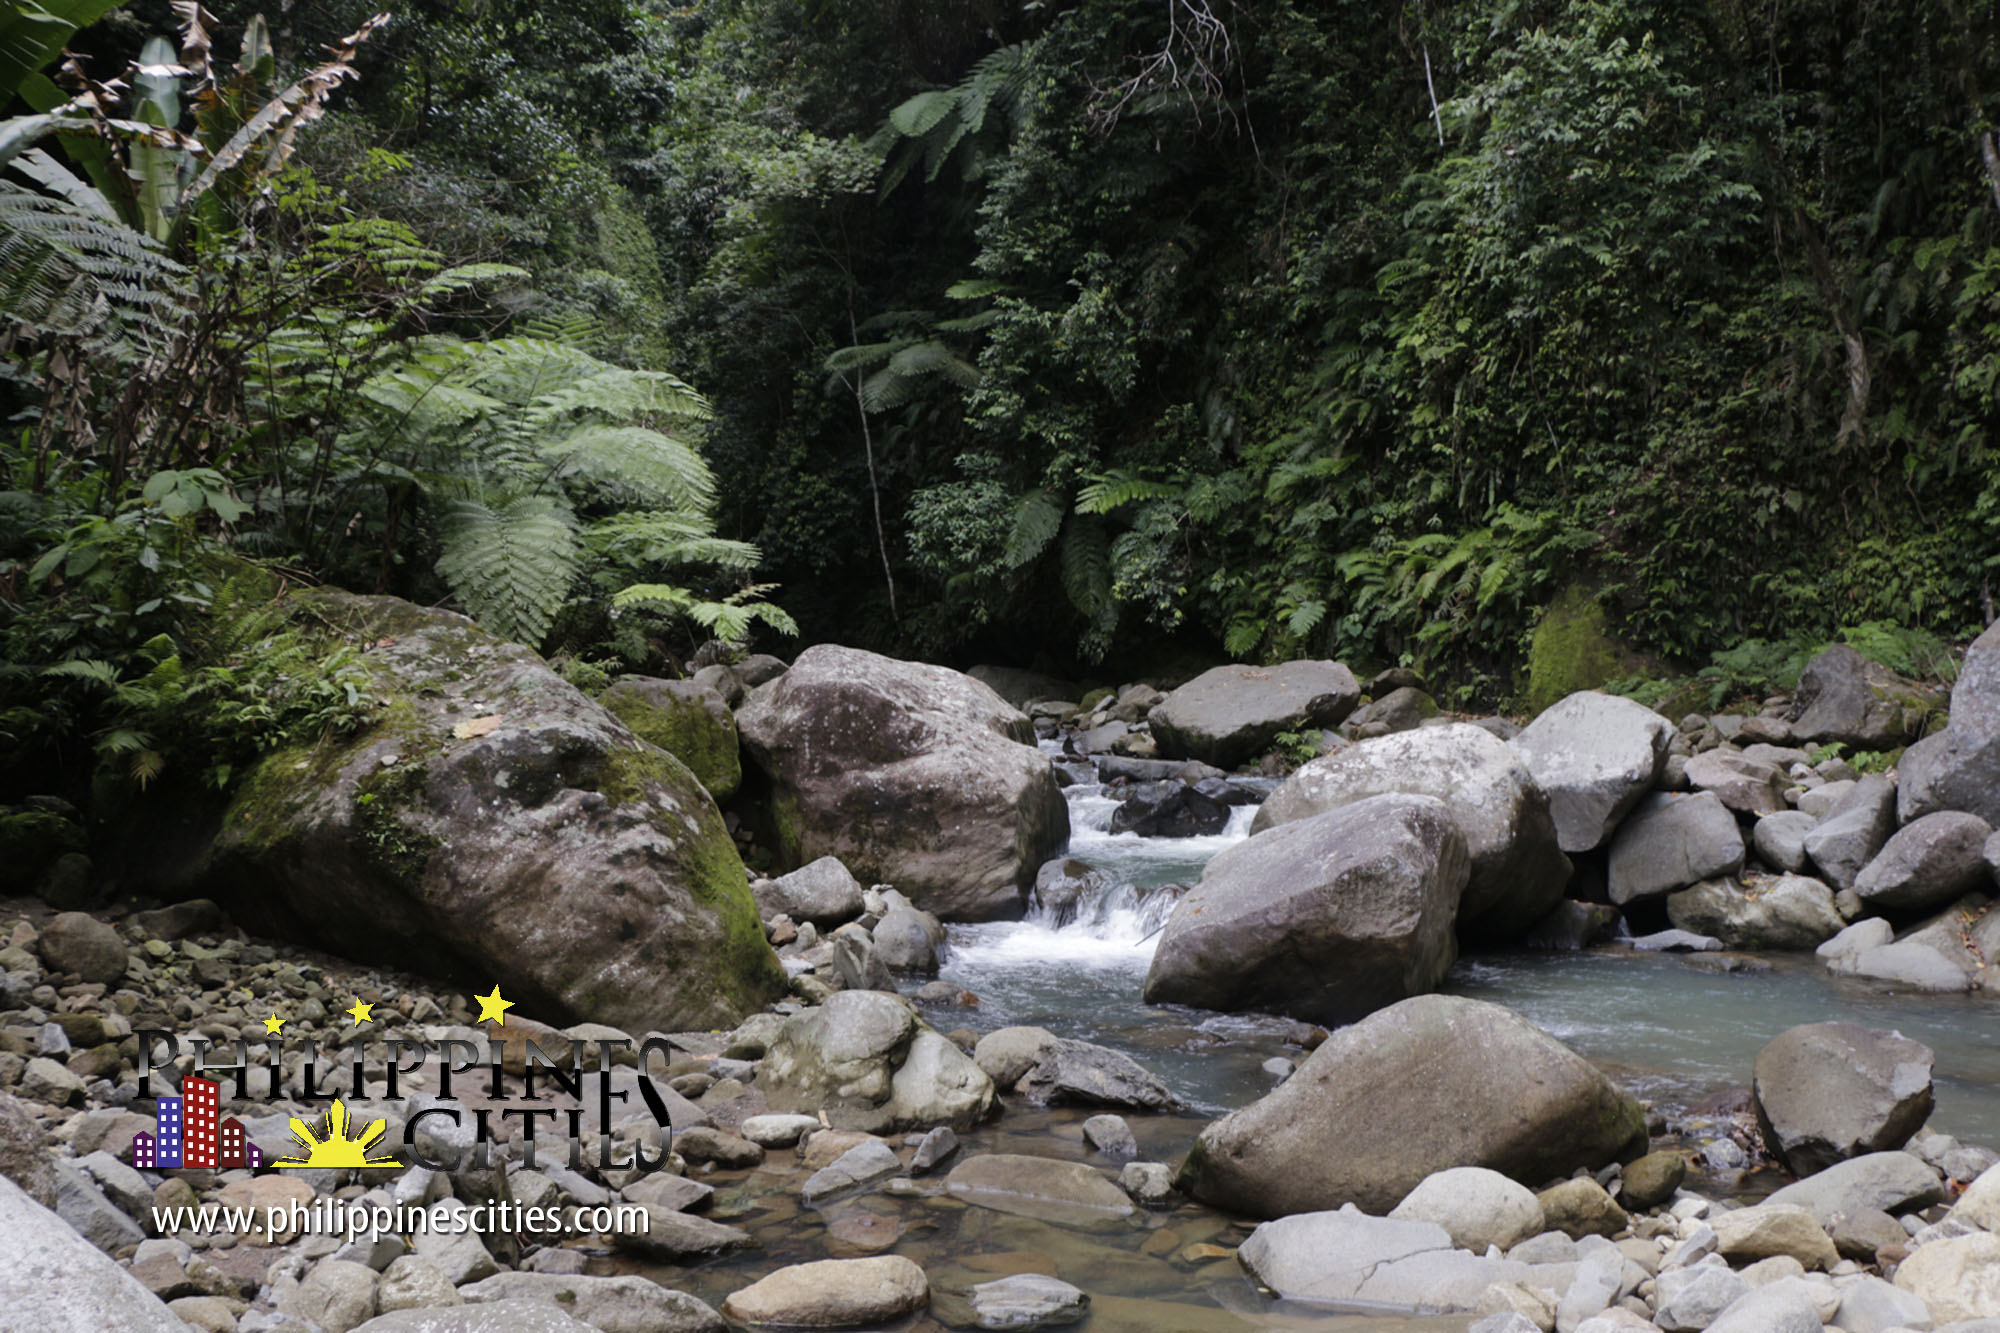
{"left": 736, "top": 642, "right": 1070, "bottom": 921}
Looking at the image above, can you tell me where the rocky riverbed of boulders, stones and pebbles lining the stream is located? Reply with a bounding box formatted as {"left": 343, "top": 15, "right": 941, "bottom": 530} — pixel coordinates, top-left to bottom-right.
{"left": 0, "top": 598, "right": 2000, "bottom": 1333}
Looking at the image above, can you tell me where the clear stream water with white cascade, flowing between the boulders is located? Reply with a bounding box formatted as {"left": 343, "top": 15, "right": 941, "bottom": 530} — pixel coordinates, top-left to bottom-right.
{"left": 640, "top": 763, "right": 2000, "bottom": 1333}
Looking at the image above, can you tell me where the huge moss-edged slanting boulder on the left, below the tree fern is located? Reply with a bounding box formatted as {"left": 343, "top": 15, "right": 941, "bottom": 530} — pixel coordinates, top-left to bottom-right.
{"left": 193, "top": 590, "right": 784, "bottom": 1033}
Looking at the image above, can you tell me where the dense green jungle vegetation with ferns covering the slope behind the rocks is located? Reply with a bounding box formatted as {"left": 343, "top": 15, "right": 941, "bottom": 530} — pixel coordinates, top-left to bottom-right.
{"left": 0, "top": 0, "right": 2000, "bottom": 800}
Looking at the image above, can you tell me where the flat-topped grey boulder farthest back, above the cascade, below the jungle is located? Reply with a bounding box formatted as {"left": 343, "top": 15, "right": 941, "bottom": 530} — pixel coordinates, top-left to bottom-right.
{"left": 1148, "top": 662, "right": 1362, "bottom": 769}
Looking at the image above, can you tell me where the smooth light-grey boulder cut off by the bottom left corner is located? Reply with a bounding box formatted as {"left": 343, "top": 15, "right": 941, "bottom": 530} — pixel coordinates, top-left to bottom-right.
{"left": 0, "top": 1179, "right": 186, "bottom": 1333}
